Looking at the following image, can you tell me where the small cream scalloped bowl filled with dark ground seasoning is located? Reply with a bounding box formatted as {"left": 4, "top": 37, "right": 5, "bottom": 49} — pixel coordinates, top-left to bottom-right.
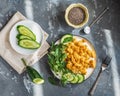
{"left": 65, "top": 3, "right": 89, "bottom": 28}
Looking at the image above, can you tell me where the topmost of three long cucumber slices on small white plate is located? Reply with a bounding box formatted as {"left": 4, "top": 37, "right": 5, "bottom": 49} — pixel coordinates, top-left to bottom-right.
{"left": 17, "top": 25, "right": 36, "bottom": 40}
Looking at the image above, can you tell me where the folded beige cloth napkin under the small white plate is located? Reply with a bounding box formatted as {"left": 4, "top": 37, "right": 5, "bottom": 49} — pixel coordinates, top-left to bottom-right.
{"left": 0, "top": 12, "right": 50, "bottom": 74}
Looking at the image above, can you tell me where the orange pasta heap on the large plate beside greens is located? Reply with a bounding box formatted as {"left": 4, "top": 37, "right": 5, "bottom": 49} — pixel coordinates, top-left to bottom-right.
{"left": 65, "top": 38, "right": 96, "bottom": 75}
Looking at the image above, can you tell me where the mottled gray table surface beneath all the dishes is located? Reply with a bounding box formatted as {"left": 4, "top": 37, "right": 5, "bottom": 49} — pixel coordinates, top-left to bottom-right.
{"left": 0, "top": 0, "right": 120, "bottom": 96}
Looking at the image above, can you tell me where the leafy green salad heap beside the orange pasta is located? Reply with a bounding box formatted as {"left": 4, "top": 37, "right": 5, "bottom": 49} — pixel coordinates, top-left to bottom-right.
{"left": 48, "top": 43, "right": 67, "bottom": 72}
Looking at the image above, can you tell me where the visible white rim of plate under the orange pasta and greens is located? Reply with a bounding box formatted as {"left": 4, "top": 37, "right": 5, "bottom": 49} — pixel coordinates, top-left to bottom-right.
{"left": 51, "top": 36, "right": 97, "bottom": 80}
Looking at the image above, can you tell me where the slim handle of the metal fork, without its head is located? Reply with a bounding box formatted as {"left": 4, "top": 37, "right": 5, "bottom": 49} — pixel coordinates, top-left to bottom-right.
{"left": 88, "top": 68, "right": 102, "bottom": 96}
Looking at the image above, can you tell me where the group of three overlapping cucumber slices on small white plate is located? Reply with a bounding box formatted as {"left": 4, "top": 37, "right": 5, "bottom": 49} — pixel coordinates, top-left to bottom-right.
{"left": 16, "top": 25, "right": 40, "bottom": 49}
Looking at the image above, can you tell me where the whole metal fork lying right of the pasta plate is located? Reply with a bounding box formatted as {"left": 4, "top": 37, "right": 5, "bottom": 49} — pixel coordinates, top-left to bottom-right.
{"left": 88, "top": 56, "right": 112, "bottom": 96}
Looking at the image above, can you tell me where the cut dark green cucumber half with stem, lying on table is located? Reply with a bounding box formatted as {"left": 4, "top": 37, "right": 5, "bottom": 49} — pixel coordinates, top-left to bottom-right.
{"left": 21, "top": 58, "right": 44, "bottom": 84}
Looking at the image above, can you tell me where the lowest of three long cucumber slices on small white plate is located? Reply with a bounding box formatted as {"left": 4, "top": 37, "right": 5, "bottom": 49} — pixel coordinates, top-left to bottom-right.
{"left": 18, "top": 39, "right": 40, "bottom": 49}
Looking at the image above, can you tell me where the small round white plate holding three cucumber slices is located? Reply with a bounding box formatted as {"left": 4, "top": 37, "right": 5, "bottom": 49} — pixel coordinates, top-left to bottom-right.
{"left": 9, "top": 20, "right": 43, "bottom": 55}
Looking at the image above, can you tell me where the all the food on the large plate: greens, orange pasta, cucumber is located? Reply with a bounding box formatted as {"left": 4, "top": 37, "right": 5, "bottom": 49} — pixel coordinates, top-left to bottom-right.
{"left": 48, "top": 34, "right": 96, "bottom": 84}
